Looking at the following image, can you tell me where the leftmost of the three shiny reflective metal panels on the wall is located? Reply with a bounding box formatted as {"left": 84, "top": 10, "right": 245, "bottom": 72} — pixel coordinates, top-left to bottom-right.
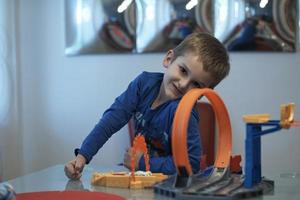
{"left": 65, "top": 0, "right": 135, "bottom": 55}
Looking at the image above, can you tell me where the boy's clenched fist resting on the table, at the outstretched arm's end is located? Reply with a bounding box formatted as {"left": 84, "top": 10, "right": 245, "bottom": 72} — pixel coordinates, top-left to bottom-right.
{"left": 65, "top": 154, "right": 86, "bottom": 180}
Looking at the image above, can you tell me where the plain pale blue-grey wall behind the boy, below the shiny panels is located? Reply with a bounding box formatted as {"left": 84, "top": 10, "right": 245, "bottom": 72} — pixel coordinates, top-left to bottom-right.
{"left": 1, "top": 0, "right": 300, "bottom": 179}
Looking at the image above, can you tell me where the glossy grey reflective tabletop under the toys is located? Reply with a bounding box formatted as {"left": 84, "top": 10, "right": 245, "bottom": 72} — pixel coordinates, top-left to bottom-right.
{"left": 3, "top": 165, "right": 300, "bottom": 200}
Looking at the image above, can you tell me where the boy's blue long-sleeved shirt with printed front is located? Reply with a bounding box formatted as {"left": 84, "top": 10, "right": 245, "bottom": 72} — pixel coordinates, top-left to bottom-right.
{"left": 76, "top": 72, "right": 201, "bottom": 174}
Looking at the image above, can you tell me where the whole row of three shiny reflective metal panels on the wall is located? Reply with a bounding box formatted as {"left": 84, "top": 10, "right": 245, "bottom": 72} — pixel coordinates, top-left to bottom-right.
{"left": 65, "top": 0, "right": 299, "bottom": 55}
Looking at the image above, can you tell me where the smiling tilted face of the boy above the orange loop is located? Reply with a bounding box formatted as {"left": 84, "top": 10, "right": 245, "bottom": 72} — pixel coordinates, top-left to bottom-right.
{"left": 161, "top": 50, "right": 213, "bottom": 100}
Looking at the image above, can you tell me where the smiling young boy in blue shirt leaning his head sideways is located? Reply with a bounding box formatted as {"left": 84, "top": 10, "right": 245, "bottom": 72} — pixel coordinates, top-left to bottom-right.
{"left": 65, "top": 33, "right": 230, "bottom": 179}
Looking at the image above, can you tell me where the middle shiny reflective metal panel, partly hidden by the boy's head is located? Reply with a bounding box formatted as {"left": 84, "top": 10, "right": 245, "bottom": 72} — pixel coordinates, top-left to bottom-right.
{"left": 136, "top": 0, "right": 212, "bottom": 53}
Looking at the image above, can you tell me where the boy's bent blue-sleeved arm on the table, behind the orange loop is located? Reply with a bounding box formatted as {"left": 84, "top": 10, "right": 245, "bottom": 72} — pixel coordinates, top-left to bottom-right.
{"left": 139, "top": 110, "right": 202, "bottom": 174}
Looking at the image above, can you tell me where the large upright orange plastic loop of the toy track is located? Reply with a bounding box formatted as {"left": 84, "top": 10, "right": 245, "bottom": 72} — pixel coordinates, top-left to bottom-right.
{"left": 172, "top": 88, "right": 232, "bottom": 176}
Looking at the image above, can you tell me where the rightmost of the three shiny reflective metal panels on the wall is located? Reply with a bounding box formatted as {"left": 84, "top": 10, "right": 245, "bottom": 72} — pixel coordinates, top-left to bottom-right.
{"left": 214, "top": 0, "right": 297, "bottom": 52}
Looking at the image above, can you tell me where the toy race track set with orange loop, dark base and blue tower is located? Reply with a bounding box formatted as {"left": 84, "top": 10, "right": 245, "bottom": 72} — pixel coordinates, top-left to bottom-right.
{"left": 154, "top": 89, "right": 299, "bottom": 200}
